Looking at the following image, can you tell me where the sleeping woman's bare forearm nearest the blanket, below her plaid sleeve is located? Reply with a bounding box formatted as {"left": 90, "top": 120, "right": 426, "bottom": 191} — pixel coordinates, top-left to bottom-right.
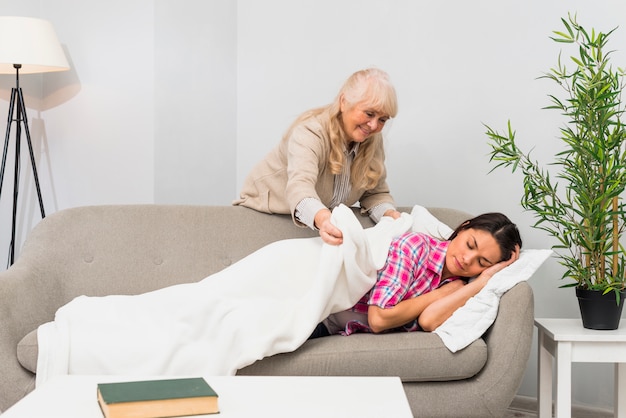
{"left": 367, "top": 280, "right": 465, "bottom": 333}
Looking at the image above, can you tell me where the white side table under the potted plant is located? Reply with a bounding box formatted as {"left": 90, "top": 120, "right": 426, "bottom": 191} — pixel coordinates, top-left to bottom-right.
{"left": 535, "top": 318, "right": 626, "bottom": 418}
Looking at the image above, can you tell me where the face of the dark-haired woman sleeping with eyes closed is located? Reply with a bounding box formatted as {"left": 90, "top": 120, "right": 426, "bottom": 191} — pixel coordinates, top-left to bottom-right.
{"left": 444, "top": 228, "right": 502, "bottom": 278}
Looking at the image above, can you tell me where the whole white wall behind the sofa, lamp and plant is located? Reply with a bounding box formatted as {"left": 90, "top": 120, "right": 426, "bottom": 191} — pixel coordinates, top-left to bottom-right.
{"left": 0, "top": 0, "right": 626, "bottom": 406}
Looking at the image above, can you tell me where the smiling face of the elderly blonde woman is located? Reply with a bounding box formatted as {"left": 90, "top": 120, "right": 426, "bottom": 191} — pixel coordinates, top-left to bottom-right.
{"left": 341, "top": 99, "right": 389, "bottom": 142}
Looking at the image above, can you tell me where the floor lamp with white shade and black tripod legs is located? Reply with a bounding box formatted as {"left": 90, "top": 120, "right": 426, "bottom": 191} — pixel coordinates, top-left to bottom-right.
{"left": 0, "top": 16, "right": 70, "bottom": 265}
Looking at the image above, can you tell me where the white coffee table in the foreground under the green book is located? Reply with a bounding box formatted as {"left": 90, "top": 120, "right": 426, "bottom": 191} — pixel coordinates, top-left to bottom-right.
{"left": 6, "top": 376, "right": 413, "bottom": 418}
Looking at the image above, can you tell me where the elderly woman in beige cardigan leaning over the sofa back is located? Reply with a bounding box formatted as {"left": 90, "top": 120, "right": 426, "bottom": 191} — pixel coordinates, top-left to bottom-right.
{"left": 233, "top": 68, "right": 400, "bottom": 245}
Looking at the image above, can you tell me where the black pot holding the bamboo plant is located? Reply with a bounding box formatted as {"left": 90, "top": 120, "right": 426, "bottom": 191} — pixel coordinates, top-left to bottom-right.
{"left": 576, "top": 287, "right": 626, "bottom": 330}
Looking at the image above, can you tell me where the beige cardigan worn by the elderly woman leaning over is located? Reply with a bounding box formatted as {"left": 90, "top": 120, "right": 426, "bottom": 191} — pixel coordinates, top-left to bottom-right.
{"left": 233, "top": 116, "right": 395, "bottom": 226}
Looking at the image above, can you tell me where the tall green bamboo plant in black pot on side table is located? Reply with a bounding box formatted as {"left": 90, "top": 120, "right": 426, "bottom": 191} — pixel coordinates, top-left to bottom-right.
{"left": 486, "top": 14, "right": 626, "bottom": 329}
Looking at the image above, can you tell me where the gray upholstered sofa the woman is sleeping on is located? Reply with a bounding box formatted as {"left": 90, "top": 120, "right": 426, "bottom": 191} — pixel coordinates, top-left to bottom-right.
{"left": 0, "top": 205, "right": 533, "bottom": 418}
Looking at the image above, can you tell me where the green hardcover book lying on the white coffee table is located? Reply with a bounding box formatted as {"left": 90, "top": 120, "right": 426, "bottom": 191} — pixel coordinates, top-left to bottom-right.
{"left": 98, "top": 377, "right": 219, "bottom": 418}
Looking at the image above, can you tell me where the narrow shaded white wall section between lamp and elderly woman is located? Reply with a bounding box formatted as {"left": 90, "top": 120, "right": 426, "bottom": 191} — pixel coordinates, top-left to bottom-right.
{"left": 153, "top": 0, "right": 237, "bottom": 205}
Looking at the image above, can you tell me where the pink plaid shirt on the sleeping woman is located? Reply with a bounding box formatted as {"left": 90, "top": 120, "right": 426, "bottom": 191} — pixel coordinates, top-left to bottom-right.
{"left": 344, "top": 232, "right": 458, "bottom": 335}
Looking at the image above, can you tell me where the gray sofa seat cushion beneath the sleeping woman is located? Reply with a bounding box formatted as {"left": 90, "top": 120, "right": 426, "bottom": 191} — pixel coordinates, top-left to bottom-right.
{"left": 237, "top": 332, "right": 487, "bottom": 382}
